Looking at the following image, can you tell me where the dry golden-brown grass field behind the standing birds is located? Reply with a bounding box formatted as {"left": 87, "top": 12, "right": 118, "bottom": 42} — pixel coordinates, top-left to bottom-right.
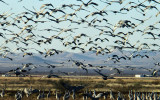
{"left": 0, "top": 76, "right": 160, "bottom": 100}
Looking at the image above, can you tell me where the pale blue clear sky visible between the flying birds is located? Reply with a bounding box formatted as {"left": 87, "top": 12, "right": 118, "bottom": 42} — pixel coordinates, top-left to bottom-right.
{"left": 0, "top": 0, "right": 160, "bottom": 52}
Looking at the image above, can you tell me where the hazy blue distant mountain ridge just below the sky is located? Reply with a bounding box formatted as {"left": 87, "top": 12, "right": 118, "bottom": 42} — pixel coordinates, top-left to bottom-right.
{"left": 0, "top": 50, "right": 160, "bottom": 66}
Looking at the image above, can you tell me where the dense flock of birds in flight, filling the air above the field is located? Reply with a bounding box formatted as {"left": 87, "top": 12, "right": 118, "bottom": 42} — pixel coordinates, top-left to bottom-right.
{"left": 0, "top": 0, "right": 160, "bottom": 95}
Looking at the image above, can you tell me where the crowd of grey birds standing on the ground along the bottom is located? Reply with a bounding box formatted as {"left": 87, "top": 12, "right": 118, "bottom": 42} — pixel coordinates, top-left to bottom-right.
{"left": 0, "top": 87, "right": 160, "bottom": 100}
